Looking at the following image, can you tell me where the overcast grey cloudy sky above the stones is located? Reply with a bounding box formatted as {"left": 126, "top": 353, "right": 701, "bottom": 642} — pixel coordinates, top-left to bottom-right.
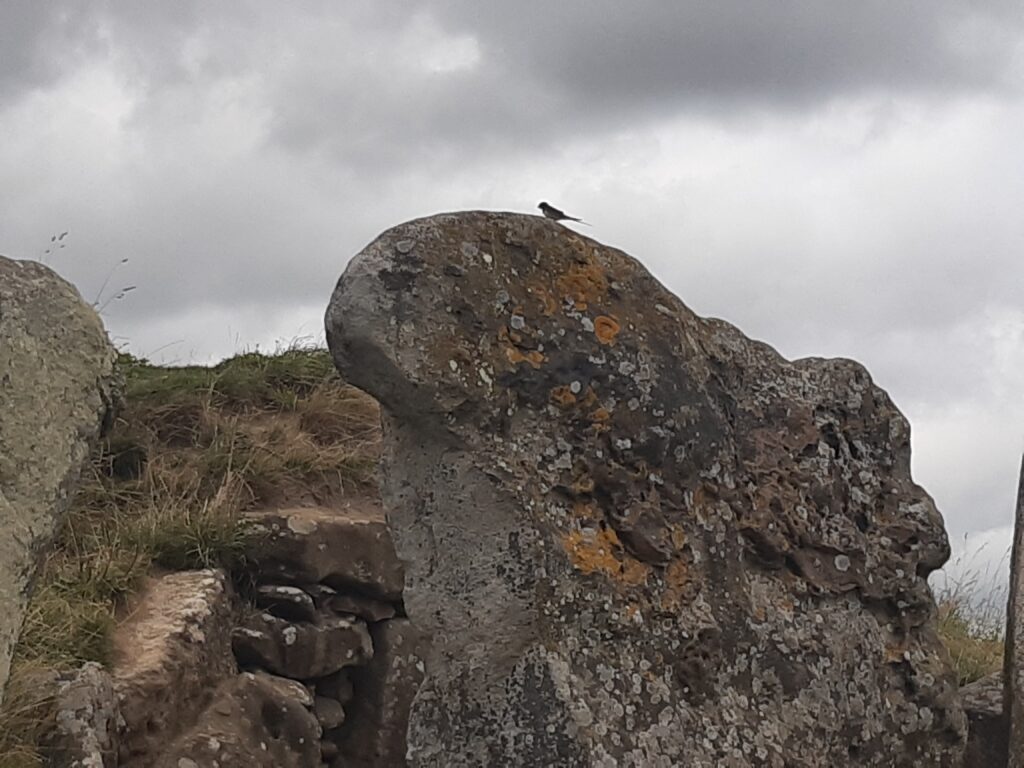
{"left": 0, "top": 0, "right": 1024, "bottom": 593}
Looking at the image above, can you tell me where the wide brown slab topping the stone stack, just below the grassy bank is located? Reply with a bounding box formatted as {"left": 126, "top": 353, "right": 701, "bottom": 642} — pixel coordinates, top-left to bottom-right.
{"left": 249, "top": 500, "right": 402, "bottom": 600}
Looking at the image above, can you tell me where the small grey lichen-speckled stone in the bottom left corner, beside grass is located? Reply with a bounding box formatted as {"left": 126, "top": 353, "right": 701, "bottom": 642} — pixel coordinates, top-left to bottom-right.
{"left": 45, "top": 662, "right": 123, "bottom": 768}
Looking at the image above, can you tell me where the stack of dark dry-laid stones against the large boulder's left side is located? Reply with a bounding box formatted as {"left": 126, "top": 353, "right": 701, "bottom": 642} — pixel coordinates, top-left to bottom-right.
{"left": 231, "top": 502, "right": 422, "bottom": 766}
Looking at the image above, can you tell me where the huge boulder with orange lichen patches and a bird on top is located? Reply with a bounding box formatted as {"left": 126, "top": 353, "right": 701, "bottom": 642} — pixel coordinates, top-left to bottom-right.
{"left": 327, "top": 212, "right": 966, "bottom": 767}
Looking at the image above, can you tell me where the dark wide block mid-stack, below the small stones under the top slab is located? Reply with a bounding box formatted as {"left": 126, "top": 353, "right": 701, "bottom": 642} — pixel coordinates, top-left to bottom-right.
{"left": 231, "top": 613, "right": 374, "bottom": 680}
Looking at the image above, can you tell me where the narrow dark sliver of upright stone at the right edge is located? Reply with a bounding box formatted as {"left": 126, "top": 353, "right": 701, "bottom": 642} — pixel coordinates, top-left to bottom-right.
{"left": 1002, "top": 456, "right": 1024, "bottom": 768}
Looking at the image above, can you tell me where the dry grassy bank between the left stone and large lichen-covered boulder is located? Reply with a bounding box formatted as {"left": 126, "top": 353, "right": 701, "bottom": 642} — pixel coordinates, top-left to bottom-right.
{"left": 0, "top": 348, "right": 380, "bottom": 768}
